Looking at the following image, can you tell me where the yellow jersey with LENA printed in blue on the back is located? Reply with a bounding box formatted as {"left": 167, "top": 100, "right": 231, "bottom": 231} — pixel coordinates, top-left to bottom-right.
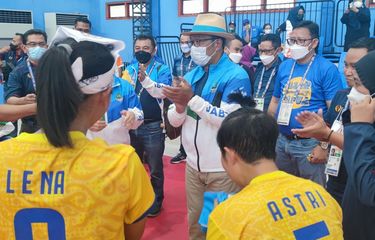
{"left": 0, "top": 132, "right": 154, "bottom": 240}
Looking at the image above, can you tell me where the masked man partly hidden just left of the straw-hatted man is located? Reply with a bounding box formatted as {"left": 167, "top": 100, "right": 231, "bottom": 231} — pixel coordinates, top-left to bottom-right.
{"left": 171, "top": 33, "right": 197, "bottom": 164}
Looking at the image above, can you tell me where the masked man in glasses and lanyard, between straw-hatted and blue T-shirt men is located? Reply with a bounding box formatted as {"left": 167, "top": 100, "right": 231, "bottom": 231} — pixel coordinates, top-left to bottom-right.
{"left": 254, "top": 34, "right": 281, "bottom": 112}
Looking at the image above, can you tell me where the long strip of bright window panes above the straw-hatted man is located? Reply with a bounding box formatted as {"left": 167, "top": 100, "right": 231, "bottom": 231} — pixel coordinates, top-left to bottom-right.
{"left": 179, "top": 0, "right": 296, "bottom": 15}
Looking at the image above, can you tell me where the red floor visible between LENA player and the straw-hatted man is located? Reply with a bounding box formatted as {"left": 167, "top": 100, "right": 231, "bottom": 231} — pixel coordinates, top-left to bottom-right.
{"left": 142, "top": 157, "right": 188, "bottom": 240}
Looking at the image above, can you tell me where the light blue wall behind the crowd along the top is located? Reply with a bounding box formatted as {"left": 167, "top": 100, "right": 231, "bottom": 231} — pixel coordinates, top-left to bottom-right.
{"left": 0, "top": 0, "right": 375, "bottom": 61}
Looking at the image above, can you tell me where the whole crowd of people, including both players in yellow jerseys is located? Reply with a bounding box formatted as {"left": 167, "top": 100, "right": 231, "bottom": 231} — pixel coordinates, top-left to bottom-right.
{"left": 0, "top": 0, "right": 375, "bottom": 240}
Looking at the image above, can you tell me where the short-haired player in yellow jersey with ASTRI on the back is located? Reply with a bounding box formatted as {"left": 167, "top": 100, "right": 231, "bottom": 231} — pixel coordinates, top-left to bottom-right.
{"left": 207, "top": 108, "right": 343, "bottom": 240}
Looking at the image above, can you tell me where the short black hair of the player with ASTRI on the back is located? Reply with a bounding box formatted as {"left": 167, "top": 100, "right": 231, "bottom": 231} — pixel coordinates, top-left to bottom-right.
{"left": 216, "top": 107, "right": 279, "bottom": 164}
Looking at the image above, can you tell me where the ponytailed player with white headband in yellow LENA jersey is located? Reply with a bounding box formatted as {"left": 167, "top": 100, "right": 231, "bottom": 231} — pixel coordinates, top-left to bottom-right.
{"left": 0, "top": 30, "right": 154, "bottom": 240}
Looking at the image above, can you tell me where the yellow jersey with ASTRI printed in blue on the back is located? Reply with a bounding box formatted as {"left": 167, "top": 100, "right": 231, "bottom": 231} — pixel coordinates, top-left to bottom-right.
{"left": 207, "top": 171, "right": 343, "bottom": 240}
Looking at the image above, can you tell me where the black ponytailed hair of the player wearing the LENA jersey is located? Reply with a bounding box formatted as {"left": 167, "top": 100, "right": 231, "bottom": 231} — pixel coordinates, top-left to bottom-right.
{"left": 36, "top": 41, "right": 115, "bottom": 147}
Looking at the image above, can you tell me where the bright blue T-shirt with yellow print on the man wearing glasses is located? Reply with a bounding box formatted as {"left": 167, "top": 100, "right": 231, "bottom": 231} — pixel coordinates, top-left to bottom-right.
{"left": 273, "top": 55, "right": 343, "bottom": 136}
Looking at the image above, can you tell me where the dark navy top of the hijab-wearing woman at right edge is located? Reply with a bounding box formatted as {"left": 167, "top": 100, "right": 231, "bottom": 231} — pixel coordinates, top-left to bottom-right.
{"left": 342, "top": 123, "right": 375, "bottom": 240}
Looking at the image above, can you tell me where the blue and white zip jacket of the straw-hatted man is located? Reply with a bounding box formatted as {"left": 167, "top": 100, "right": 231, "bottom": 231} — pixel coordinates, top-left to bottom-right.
{"left": 168, "top": 54, "right": 251, "bottom": 172}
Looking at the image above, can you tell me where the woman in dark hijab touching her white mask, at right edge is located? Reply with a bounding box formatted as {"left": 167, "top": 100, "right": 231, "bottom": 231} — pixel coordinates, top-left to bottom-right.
{"left": 342, "top": 51, "right": 375, "bottom": 240}
